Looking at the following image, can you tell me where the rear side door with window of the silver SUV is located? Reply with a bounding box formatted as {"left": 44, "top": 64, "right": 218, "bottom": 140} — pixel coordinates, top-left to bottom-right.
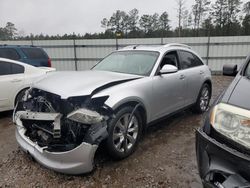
{"left": 178, "top": 50, "right": 204, "bottom": 106}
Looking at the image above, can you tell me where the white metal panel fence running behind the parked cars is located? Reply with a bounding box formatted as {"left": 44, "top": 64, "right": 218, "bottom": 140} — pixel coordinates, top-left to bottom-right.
{"left": 0, "top": 36, "right": 250, "bottom": 72}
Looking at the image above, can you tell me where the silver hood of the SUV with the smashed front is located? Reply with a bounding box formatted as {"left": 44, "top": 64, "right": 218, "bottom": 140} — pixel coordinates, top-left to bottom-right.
{"left": 33, "top": 70, "right": 142, "bottom": 99}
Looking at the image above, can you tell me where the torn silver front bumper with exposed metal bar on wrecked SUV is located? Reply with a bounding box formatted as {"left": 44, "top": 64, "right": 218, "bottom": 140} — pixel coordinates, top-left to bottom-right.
{"left": 13, "top": 111, "right": 107, "bottom": 174}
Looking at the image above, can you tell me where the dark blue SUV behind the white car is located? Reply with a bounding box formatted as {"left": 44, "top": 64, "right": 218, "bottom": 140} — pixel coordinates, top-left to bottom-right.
{"left": 0, "top": 45, "right": 51, "bottom": 67}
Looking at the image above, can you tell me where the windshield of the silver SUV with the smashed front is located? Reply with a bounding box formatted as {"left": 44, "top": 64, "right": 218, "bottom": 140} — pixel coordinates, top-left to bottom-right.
{"left": 93, "top": 51, "right": 159, "bottom": 76}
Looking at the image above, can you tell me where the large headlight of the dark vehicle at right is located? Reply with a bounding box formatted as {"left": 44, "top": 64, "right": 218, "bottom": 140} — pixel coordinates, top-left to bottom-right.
{"left": 210, "top": 103, "right": 250, "bottom": 148}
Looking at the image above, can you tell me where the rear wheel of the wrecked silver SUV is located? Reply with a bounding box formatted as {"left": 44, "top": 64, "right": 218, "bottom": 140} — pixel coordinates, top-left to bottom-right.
{"left": 193, "top": 83, "right": 211, "bottom": 114}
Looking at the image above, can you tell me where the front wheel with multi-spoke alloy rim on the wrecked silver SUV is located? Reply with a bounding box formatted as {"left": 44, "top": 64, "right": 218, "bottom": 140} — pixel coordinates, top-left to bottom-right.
{"left": 106, "top": 106, "right": 142, "bottom": 160}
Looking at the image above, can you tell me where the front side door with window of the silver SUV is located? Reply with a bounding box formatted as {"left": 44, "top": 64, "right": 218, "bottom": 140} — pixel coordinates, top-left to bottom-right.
{"left": 152, "top": 51, "right": 186, "bottom": 119}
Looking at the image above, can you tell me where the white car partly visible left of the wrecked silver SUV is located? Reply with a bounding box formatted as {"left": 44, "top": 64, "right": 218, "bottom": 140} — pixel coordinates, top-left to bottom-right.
{"left": 0, "top": 58, "right": 55, "bottom": 112}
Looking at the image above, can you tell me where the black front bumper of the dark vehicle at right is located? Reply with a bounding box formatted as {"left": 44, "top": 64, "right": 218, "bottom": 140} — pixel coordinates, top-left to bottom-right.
{"left": 196, "top": 128, "right": 250, "bottom": 188}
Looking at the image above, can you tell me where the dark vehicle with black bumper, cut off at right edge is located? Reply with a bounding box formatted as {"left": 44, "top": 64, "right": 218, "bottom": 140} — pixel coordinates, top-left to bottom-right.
{"left": 196, "top": 56, "right": 250, "bottom": 188}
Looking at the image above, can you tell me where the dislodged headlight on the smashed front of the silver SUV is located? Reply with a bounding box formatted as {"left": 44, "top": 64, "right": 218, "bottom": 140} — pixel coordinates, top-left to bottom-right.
{"left": 67, "top": 108, "right": 104, "bottom": 124}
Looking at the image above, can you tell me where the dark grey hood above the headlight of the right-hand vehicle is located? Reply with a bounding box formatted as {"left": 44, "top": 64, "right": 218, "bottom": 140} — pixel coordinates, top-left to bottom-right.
{"left": 228, "top": 77, "right": 250, "bottom": 110}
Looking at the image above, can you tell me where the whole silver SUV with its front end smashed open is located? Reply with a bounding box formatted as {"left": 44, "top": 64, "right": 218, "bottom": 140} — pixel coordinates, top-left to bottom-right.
{"left": 14, "top": 44, "right": 212, "bottom": 174}
